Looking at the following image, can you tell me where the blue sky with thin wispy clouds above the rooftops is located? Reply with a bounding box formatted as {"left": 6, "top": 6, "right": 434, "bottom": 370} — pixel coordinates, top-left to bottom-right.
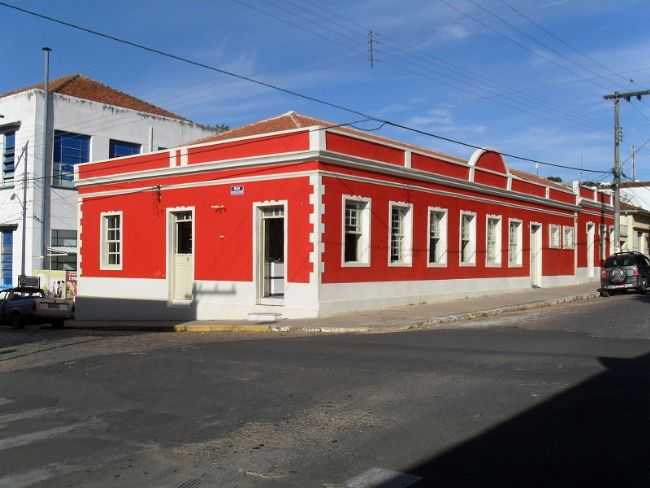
{"left": 0, "top": 0, "right": 650, "bottom": 181}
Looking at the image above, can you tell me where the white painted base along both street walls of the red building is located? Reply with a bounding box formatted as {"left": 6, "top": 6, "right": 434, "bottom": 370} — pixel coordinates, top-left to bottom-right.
{"left": 76, "top": 268, "right": 600, "bottom": 321}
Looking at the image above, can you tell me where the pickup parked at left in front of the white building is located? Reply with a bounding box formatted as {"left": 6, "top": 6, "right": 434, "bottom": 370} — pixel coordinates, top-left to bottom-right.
{"left": 0, "top": 287, "right": 74, "bottom": 329}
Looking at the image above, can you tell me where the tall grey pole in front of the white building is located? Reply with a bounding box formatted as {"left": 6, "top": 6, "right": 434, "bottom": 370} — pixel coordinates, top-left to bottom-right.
{"left": 41, "top": 47, "right": 52, "bottom": 269}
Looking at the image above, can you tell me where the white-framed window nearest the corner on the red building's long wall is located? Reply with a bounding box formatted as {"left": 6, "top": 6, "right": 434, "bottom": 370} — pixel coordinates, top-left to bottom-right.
{"left": 343, "top": 195, "right": 370, "bottom": 265}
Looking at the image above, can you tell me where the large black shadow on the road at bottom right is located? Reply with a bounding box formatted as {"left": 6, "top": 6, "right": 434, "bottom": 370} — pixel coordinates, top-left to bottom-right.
{"left": 381, "top": 352, "right": 650, "bottom": 488}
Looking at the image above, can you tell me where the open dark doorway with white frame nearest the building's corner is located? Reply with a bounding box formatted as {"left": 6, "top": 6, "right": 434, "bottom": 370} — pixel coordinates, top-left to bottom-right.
{"left": 255, "top": 205, "right": 286, "bottom": 305}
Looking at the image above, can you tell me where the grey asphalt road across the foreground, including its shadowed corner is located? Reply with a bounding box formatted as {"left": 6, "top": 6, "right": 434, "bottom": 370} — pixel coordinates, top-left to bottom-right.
{"left": 0, "top": 295, "right": 650, "bottom": 488}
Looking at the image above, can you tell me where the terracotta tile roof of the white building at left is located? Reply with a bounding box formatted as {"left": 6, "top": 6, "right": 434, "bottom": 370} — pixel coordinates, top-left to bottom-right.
{"left": 0, "top": 73, "right": 188, "bottom": 120}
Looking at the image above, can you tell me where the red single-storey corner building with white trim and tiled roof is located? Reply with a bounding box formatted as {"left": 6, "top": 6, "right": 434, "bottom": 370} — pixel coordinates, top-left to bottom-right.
{"left": 75, "top": 112, "right": 613, "bottom": 319}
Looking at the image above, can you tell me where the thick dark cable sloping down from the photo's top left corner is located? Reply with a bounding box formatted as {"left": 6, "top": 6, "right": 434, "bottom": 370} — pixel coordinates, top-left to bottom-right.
{"left": 0, "top": 0, "right": 608, "bottom": 174}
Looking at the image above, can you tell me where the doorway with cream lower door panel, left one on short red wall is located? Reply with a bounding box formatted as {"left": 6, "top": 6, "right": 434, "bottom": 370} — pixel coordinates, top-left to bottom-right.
{"left": 169, "top": 210, "right": 194, "bottom": 302}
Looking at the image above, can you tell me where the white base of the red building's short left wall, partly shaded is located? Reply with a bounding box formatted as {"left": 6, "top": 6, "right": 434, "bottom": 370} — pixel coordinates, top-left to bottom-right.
{"left": 75, "top": 277, "right": 318, "bottom": 321}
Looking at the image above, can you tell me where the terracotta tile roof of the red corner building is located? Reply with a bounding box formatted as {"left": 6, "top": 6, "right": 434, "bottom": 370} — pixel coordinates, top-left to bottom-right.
{"left": 194, "top": 111, "right": 467, "bottom": 164}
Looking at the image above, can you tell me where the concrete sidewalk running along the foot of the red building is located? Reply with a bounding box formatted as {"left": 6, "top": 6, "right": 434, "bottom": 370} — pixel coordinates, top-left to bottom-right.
{"left": 66, "top": 283, "right": 598, "bottom": 334}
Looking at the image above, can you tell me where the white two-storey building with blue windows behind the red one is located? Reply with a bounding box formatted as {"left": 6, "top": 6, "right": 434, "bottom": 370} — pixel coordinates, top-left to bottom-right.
{"left": 0, "top": 74, "right": 216, "bottom": 287}
